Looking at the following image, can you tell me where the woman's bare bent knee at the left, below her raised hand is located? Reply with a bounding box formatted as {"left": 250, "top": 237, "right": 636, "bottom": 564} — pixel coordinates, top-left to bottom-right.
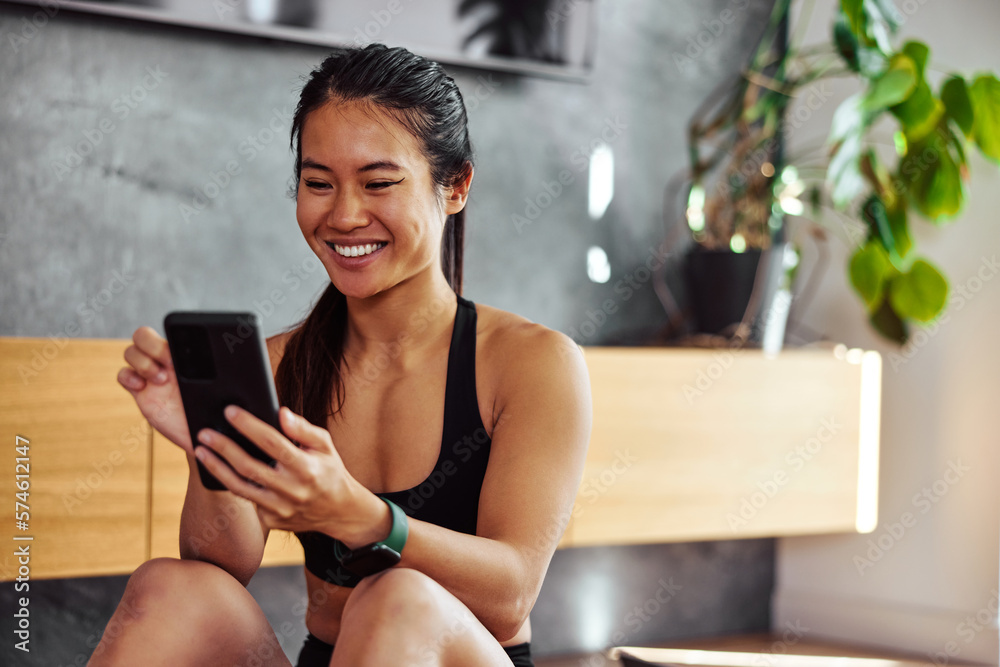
{"left": 88, "top": 558, "right": 290, "bottom": 667}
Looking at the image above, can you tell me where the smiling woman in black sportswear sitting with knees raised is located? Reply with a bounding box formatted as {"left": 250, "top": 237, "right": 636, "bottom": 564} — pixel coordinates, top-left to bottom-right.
{"left": 90, "top": 45, "right": 591, "bottom": 666}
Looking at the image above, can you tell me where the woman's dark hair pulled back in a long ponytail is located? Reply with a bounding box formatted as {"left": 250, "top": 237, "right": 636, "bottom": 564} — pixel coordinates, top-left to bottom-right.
{"left": 276, "top": 44, "right": 472, "bottom": 428}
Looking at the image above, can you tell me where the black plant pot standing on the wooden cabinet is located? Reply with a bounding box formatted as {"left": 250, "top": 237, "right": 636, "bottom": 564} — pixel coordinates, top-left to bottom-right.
{"left": 684, "top": 246, "right": 761, "bottom": 334}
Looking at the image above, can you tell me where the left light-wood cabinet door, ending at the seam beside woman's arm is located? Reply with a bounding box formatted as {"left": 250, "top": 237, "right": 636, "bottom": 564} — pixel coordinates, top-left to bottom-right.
{"left": 0, "top": 338, "right": 152, "bottom": 579}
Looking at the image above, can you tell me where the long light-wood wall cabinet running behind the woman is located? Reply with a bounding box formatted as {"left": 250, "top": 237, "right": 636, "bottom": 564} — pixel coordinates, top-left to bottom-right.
{"left": 0, "top": 337, "right": 881, "bottom": 580}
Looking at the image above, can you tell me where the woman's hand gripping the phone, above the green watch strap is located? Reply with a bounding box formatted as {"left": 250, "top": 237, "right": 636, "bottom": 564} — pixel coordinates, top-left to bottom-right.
{"left": 195, "top": 405, "right": 361, "bottom": 537}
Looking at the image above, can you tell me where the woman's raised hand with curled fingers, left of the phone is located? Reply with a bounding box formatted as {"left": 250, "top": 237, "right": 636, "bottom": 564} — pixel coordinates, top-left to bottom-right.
{"left": 118, "top": 327, "right": 194, "bottom": 454}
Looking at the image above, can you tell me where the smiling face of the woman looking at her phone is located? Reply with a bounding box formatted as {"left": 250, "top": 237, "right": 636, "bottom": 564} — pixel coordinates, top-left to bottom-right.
{"left": 296, "top": 102, "right": 465, "bottom": 298}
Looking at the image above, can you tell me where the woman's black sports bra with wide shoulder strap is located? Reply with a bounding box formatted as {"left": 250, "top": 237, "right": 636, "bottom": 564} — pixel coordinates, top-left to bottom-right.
{"left": 295, "top": 296, "right": 491, "bottom": 587}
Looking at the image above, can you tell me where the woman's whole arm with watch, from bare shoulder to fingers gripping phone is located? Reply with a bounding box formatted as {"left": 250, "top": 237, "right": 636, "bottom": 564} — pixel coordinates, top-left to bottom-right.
{"left": 196, "top": 324, "right": 591, "bottom": 641}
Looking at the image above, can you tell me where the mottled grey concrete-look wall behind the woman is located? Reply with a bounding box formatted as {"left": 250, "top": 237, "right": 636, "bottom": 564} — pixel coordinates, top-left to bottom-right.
{"left": 0, "top": 0, "right": 773, "bottom": 665}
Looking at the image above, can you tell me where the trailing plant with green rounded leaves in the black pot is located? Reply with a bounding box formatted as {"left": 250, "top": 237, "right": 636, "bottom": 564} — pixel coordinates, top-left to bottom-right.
{"left": 685, "top": 0, "right": 1000, "bottom": 344}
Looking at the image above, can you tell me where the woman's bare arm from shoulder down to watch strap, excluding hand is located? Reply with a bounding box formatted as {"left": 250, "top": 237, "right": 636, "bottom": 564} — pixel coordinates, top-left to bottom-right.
{"left": 386, "top": 325, "right": 591, "bottom": 641}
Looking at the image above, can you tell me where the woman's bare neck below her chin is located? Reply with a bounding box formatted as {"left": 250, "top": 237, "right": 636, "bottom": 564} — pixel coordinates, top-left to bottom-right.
{"left": 344, "top": 269, "right": 458, "bottom": 366}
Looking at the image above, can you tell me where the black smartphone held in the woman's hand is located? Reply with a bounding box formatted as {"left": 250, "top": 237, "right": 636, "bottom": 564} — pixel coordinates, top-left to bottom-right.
{"left": 163, "top": 311, "right": 281, "bottom": 491}
